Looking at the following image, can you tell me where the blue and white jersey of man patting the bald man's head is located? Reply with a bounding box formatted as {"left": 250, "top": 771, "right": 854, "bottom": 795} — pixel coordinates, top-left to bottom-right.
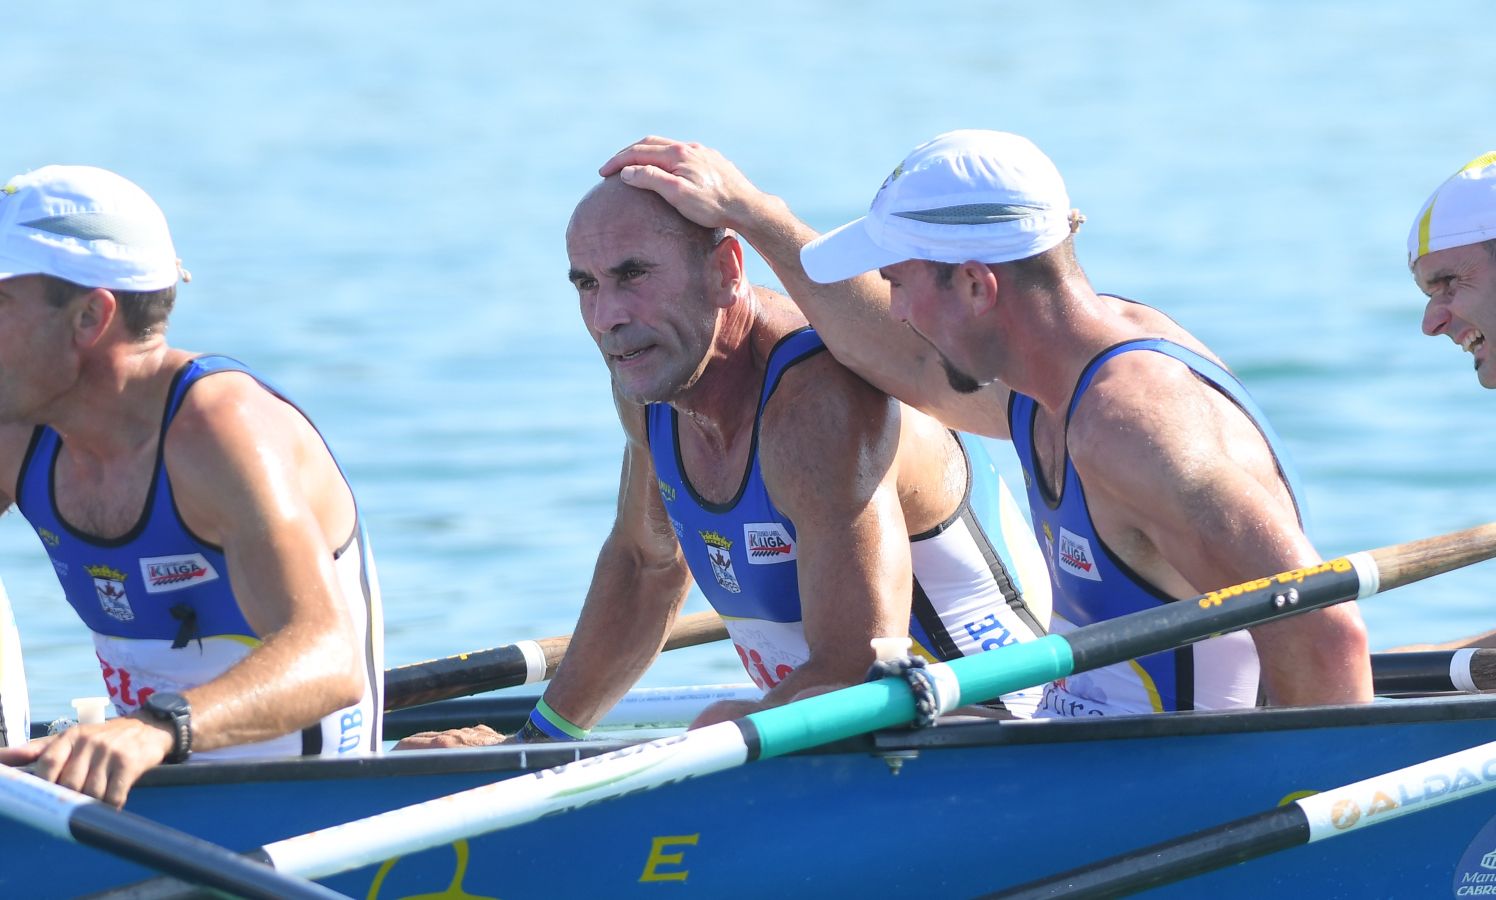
{"left": 1008, "top": 339, "right": 1299, "bottom": 716}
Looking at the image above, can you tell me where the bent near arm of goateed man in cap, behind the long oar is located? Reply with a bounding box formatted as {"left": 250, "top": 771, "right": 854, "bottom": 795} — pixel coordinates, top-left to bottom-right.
{"left": 1071, "top": 354, "right": 1372, "bottom": 706}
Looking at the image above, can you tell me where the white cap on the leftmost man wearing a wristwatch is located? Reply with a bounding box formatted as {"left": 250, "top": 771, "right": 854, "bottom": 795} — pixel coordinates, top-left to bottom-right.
{"left": 0, "top": 166, "right": 186, "bottom": 292}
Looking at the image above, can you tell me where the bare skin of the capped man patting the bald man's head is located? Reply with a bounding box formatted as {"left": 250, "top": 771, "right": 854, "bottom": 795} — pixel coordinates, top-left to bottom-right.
{"left": 600, "top": 138, "right": 1372, "bottom": 706}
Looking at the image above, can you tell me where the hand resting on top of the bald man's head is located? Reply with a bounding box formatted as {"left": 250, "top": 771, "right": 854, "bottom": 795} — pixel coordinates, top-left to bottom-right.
{"left": 598, "top": 136, "right": 764, "bottom": 230}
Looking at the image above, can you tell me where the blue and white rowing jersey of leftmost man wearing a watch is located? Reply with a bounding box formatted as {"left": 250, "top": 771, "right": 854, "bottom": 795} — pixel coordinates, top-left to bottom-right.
{"left": 16, "top": 356, "right": 383, "bottom": 758}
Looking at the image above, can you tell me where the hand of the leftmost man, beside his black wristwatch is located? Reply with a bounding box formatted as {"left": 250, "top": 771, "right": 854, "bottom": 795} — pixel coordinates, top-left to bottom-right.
{"left": 0, "top": 716, "right": 174, "bottom": 807}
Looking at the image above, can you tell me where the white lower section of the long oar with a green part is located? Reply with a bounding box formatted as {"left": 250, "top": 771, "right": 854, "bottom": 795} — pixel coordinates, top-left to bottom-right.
{"left": 263, "top": 722, "right": 748, "bottom": 878}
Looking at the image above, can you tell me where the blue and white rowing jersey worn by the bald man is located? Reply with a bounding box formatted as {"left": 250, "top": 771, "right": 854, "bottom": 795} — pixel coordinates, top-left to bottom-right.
{"left": 646, "top": 327, "right": 1049, "bottom": 716}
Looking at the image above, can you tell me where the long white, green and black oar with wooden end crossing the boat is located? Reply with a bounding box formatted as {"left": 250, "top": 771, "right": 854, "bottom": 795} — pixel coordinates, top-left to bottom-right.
{"left": 99, "top": 523, "right": 1496, "bottom": 878}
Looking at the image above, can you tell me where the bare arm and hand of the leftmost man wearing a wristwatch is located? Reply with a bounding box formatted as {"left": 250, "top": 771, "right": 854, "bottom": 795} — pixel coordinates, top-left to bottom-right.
{"left": 6, "top": 374, "right": 364, "bottom": 806}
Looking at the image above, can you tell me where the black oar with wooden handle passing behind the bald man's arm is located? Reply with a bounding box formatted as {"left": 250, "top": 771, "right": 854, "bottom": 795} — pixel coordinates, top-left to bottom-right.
{"left": 384, "top": 613, "right": 727, "bottom": 710}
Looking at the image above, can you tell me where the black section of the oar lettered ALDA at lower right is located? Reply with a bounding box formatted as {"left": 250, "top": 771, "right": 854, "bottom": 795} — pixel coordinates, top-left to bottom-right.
{"left": 983, "top": 803, "right": 1309, "bottom": 900}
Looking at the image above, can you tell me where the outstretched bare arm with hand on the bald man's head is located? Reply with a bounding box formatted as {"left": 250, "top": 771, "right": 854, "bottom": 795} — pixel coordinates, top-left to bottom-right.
{"left": 600, "top": 138, "right": 1007, "bottom": 438}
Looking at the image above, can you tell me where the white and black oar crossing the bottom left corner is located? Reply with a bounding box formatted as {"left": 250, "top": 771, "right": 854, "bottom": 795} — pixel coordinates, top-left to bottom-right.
{"left": 0, "top": 765, "right": 343, "bottom": 900}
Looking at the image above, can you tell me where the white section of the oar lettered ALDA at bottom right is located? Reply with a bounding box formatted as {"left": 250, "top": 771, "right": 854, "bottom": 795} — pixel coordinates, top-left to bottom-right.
{"left": 1297, "top": 732, "right": 1496, "bottom": 843}
